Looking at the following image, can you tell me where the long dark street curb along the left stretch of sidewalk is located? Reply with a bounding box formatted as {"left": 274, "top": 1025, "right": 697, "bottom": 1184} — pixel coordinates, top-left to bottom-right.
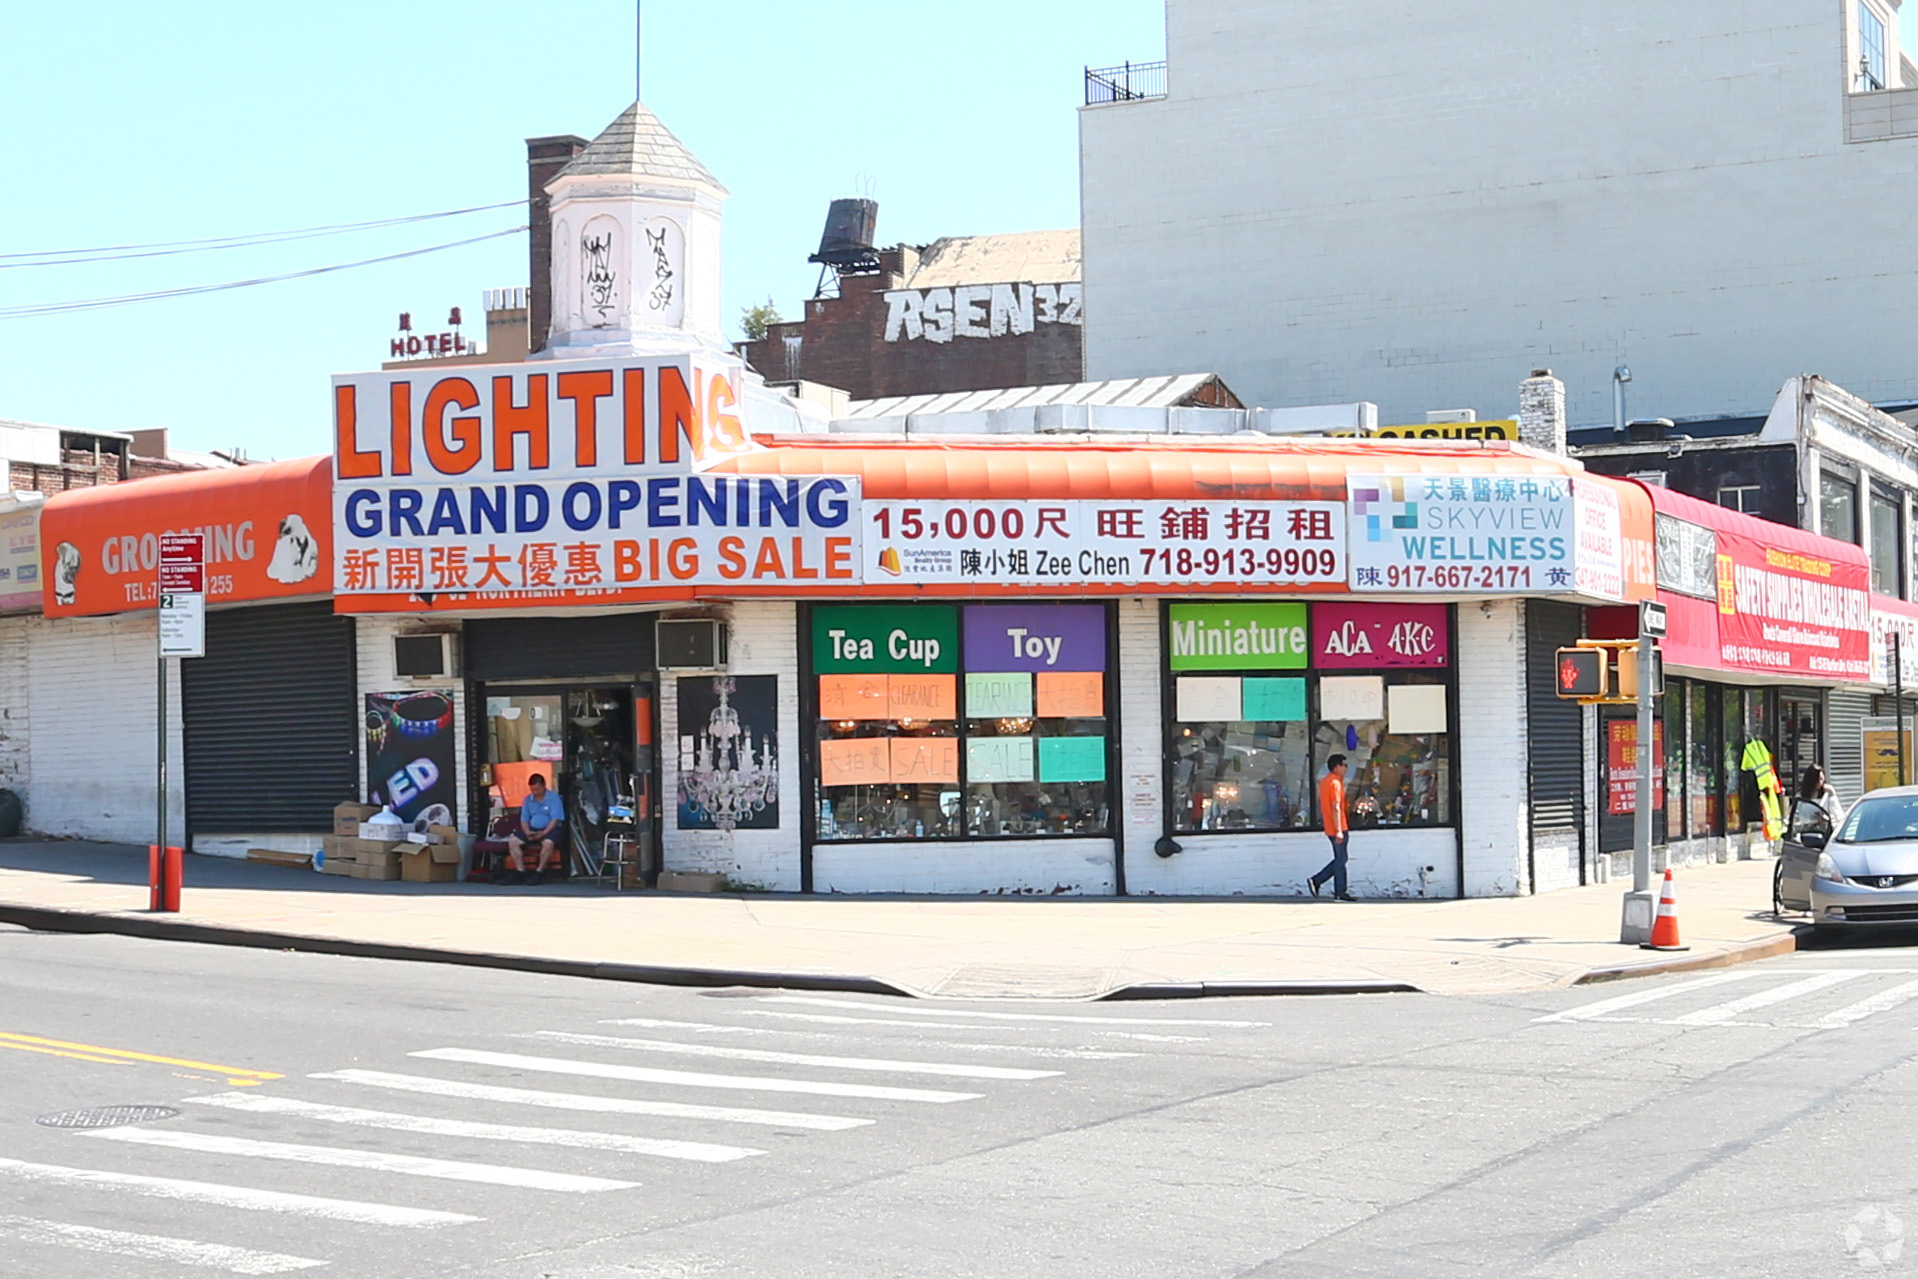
{"left": 0, "top": 903, "right": 913, "bottom": 999}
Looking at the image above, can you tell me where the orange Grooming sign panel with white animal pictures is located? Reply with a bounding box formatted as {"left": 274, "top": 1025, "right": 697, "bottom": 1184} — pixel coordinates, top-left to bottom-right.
{"left": 40, "top": 458, "right": 334, "bottom": 617}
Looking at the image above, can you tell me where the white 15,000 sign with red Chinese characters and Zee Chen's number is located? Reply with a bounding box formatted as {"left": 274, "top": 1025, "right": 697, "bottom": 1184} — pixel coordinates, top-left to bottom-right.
{"left": 861, "top": 500, "right": 1346, "bottom": 587}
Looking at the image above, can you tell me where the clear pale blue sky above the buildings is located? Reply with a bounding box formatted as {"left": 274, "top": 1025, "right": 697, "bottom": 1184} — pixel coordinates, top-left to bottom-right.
{"left": 0, "top": 0, "right": 1164, "bottom": 458}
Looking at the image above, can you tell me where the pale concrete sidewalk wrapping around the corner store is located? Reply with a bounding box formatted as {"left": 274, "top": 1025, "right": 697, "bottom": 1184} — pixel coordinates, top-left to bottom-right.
{"left": 0, "top": 840, "right": 1793, "bottom": 999}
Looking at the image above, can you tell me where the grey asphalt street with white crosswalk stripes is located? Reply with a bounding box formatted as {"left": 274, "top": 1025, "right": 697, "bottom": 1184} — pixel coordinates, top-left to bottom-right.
{"left": 0, "top": 928, "right": 1918, "bottom": 1279}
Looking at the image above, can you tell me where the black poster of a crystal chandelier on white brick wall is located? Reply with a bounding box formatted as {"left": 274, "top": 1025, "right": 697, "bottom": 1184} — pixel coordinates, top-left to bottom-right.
{"left": 679, "top": 675, "right": 779, "bottom": 830}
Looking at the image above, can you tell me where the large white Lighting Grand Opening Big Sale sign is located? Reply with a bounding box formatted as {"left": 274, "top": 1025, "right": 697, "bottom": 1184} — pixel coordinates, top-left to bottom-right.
{"left": 334, "top": 357, "right": 859, "bottom": 612}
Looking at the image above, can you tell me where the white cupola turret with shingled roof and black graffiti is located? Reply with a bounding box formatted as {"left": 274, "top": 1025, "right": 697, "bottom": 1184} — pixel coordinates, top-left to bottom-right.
{"left": 533, "top": 102, "right": 727, "bottom": 359}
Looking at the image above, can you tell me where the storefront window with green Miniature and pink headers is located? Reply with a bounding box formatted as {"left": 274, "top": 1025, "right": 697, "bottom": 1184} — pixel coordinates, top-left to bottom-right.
{"left": 1166, "top": 604, "right": 1452, "bottom": 832}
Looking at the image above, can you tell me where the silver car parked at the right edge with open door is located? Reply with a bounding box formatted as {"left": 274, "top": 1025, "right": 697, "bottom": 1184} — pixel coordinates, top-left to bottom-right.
{"left": 1774, "top": 786, "right": 1918, "bottom": 930}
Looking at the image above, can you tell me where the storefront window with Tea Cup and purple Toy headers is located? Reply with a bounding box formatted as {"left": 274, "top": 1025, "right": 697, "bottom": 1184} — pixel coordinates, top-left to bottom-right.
{"left": 811, "top": 604, "right": 1111, "bottom": 840}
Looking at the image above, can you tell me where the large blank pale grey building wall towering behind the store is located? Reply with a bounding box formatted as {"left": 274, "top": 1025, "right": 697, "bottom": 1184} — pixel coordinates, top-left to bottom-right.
{"left": 1080, "top": 0, "right": 1918, "bottom": 424}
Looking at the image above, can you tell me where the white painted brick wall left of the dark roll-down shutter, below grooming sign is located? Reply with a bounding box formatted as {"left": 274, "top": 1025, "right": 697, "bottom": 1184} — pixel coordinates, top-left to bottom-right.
{"left": 27, "top": 612, "right": 186, "bottom": 844}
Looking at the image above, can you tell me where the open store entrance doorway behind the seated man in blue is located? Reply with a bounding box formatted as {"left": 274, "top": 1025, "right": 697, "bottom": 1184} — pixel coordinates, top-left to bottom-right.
{"left": 481, "top": 679, "right": 658, "bottom": 888}
